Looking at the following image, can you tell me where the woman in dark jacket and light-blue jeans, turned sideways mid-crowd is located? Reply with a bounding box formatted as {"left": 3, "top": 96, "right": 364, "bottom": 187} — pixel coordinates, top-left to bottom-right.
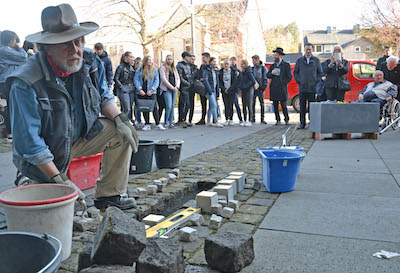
{"left": 203, "top": 57, "right": 224, "bottom": 128}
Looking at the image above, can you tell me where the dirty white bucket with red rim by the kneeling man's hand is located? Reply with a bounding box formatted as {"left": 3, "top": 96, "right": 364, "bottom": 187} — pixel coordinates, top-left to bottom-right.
{"left": 0, "top": 184, "right": 78, "bottom": 261}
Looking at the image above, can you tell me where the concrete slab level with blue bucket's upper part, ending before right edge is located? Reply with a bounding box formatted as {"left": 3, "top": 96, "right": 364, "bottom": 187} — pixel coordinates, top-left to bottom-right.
{"left": 301, "top": 156, "right": 389, "bottom": 173}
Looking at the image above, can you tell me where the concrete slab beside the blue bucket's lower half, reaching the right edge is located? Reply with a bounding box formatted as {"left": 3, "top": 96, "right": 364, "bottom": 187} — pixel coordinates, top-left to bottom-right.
{"left": 296, "top": 169, "right": 400, "bottom": 197}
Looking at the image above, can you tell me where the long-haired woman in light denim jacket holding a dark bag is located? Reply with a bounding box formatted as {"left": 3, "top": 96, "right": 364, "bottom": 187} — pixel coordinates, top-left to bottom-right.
{"left": 134, "top": 56, "right": 165, "bottom": 131}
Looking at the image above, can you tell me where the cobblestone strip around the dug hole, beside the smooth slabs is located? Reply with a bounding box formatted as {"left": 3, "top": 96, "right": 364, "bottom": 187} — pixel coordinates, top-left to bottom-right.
{"left": 59, "top": 126, "right": 314, "bottom": 273}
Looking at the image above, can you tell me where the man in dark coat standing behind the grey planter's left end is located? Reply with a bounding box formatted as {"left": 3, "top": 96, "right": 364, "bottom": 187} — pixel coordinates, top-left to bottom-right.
{"left": 293, "top": 43, "right": 322, "bottom": 129}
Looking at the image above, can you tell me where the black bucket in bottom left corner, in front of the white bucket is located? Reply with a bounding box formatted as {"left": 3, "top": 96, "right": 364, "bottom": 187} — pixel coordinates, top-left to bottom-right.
{"left": 0, "top": 232, "right": 61, "bottom": 273}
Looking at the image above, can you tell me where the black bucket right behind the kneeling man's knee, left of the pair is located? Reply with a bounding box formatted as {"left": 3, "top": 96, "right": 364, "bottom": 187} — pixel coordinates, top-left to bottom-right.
{"left": 129, "top": 140, "right": 154, "bottom": 174}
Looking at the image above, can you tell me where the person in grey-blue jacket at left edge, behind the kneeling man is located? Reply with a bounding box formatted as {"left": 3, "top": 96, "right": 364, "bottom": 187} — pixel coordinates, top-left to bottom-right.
{"left": 0, "top": 30, "right": 28, "bottom": 142}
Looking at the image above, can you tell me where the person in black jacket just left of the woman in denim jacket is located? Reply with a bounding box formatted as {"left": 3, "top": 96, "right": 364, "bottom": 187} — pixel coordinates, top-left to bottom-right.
{"left": 114, "top": 51, "right": 135, "bottom": 120}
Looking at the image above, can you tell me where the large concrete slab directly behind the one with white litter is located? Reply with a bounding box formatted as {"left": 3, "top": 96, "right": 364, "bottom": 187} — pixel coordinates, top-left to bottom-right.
{"left": 260, "top": 191, "right": 400, "bottom": 243}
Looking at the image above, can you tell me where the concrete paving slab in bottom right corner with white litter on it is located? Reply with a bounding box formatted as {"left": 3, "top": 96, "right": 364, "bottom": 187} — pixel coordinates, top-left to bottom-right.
{"left": 241, "top": 229, "right": 400, "bottom": 273}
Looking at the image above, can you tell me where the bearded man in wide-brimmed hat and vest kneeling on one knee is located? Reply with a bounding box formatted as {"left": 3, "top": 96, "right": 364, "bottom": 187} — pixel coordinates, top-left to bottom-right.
{"left": 7, "top": 4, "right": 138, "bottom": 209}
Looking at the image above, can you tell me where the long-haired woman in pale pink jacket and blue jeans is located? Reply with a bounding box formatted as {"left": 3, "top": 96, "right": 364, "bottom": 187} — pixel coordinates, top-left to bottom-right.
{"left": 160, "top": 55, "right": 181, "bottom": 128}
